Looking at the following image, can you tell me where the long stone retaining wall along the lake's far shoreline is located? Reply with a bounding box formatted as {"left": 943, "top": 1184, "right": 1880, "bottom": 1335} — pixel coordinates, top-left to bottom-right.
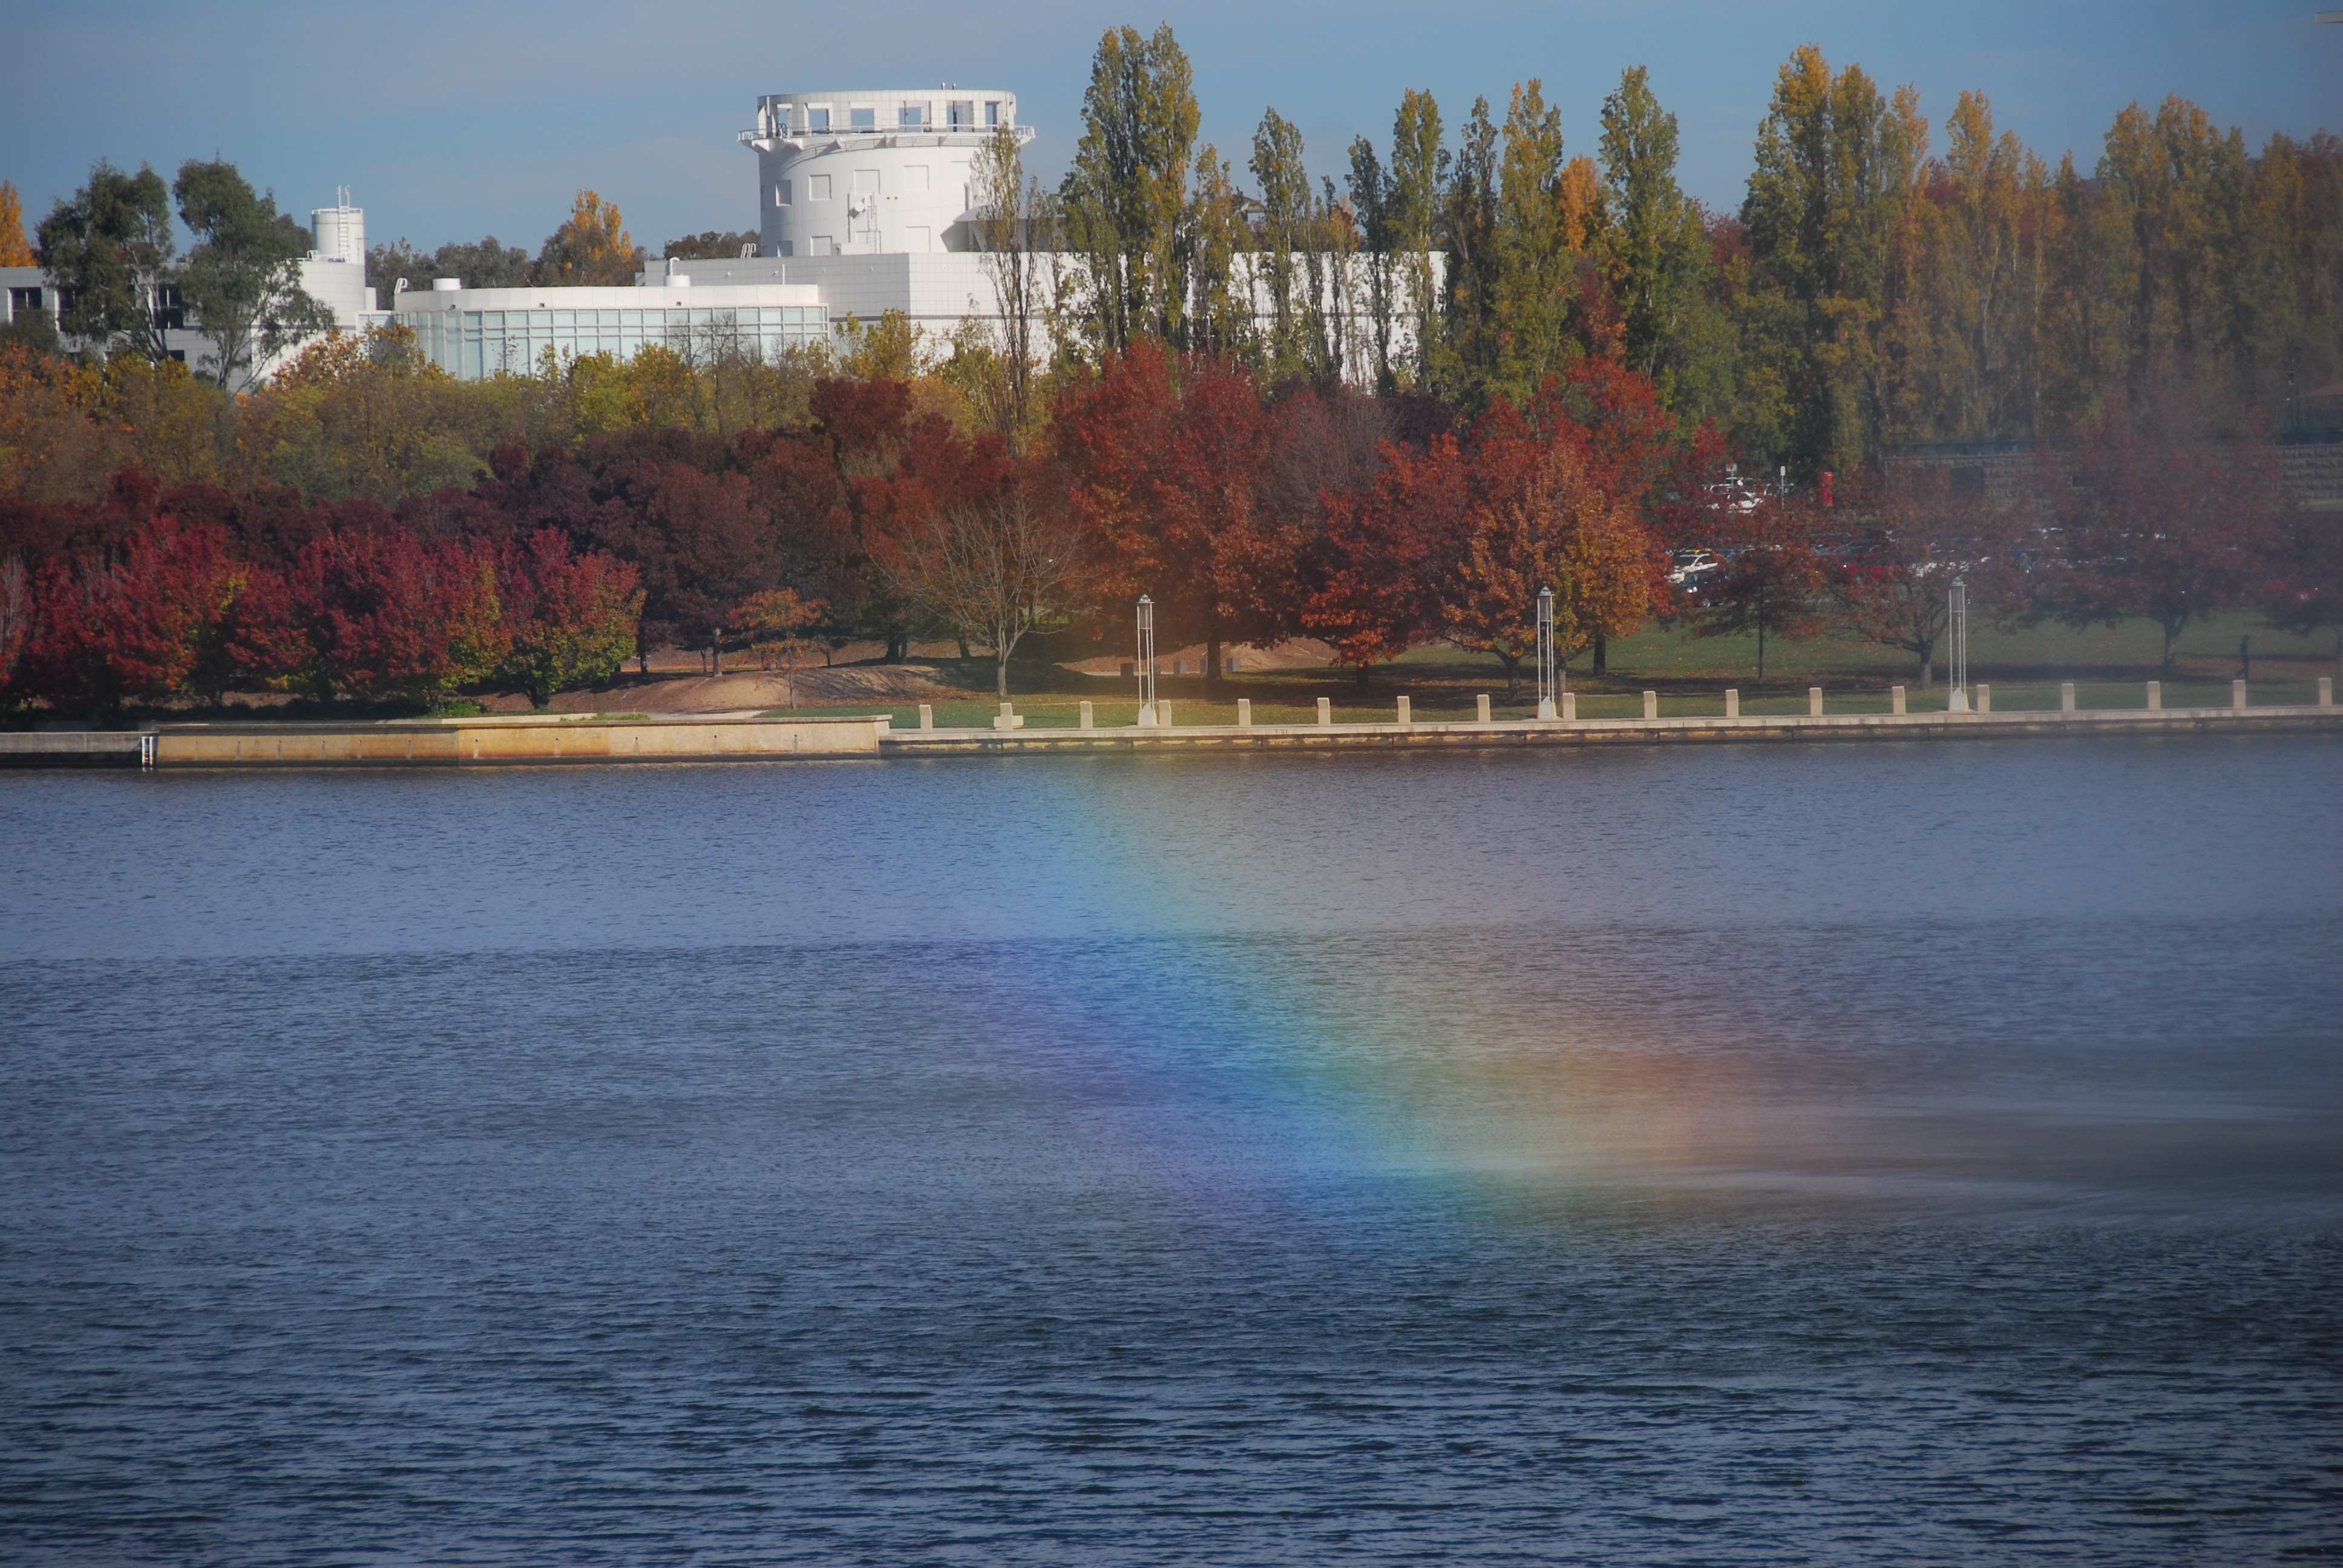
{"left": 0, "top": 705, "right": 2343, "bottom": 769}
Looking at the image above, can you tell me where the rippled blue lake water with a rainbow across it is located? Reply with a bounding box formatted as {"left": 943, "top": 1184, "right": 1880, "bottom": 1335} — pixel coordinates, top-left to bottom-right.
{"left": 0, "top": 738, "right": 2343, "bottom": 1566}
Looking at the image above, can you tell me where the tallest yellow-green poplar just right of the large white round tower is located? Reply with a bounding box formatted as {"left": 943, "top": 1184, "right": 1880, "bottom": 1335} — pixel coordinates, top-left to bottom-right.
{"left": 1059, "top": 24, "right": 1198, "bottom": 354}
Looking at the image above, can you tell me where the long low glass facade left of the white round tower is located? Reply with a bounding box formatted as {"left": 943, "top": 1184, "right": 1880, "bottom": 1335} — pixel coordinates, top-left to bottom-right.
{"left": 398, "top": 305, "right": 830, "bottom": 382}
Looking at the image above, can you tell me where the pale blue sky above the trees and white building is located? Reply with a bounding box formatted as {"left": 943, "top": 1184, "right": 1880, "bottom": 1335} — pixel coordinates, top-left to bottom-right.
{"left": 0, "top": 0, "right": 2343, "bottom": 251}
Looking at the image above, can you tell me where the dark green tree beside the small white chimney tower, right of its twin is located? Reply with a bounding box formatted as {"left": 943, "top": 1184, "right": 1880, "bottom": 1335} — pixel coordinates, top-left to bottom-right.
{"left": 171, "top": 159, "right": 333, "bottom": 389}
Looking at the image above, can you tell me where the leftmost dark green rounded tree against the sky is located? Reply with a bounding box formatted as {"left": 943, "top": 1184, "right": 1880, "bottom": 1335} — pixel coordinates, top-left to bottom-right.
{"left": 40, "top": 159, "right": 178, "bottom": 361}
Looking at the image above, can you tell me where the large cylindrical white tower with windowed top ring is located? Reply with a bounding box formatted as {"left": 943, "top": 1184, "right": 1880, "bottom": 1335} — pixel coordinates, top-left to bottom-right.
{"left": 741, "top": 87, "right": 1034, "bottom": 258}
